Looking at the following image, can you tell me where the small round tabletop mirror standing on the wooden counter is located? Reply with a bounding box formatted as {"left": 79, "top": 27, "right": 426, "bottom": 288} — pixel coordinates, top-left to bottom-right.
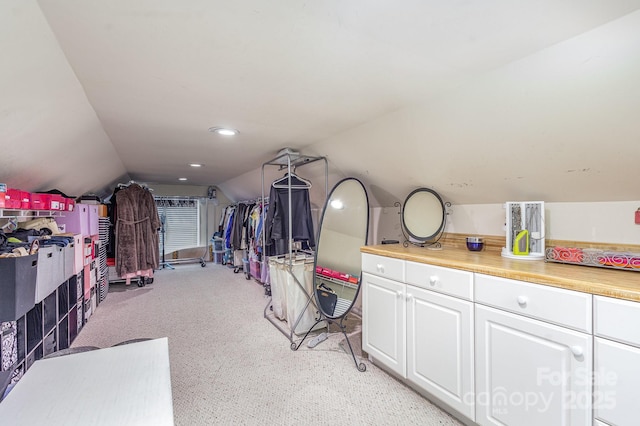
{"left": 402, "top": 188, "right": 445, "bottom": 244}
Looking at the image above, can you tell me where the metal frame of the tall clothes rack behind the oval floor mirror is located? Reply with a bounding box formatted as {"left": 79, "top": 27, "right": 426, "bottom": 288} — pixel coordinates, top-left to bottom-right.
{"left": 261, "top": 153, "right": 329, "bottom": 350}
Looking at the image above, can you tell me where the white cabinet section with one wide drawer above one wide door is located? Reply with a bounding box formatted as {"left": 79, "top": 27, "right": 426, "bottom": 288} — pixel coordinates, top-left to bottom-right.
{"left": 475, "top": 274, "right": 593, "bottom": 426}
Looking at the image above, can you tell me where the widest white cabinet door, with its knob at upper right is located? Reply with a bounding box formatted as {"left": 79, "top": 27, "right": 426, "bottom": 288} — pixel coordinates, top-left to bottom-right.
{"left": 475, "top": 304, "right": 593, "bottom": 426}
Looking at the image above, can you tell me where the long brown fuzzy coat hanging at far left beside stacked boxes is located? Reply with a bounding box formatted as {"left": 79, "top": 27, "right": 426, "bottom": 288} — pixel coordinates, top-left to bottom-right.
{"left": 114, "top": 183, "right": 161, "bottom": 277}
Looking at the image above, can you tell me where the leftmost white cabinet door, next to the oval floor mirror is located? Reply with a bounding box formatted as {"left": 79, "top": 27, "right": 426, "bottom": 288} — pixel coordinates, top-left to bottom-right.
{"left": 361, "top": 273, "right": 407, "bottom": 377}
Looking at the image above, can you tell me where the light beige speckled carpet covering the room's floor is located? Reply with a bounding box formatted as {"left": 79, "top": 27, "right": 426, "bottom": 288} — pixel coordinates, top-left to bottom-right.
{"left": 73, "top": 264, "right": 460, "bottom": 425}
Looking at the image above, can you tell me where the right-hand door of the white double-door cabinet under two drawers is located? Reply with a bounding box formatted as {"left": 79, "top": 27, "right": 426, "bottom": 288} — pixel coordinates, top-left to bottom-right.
{"left": 407, "top": 286, "right": 475, "bottom": 420}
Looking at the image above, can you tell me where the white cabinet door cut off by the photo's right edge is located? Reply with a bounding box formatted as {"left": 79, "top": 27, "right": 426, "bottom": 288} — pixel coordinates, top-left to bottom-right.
{"left": 593, "top": 337, "right": 640, "bottom": 426}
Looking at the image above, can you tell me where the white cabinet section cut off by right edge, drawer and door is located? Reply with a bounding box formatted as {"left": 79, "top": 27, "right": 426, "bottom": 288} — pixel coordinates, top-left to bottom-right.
{"left": 593, "top": 296, "right": 640, "bottom": 426}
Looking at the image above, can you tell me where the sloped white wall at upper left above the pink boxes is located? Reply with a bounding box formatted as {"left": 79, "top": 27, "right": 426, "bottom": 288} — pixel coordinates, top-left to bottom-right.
{"left": 0, "top": 0, "right": 126, "bottom": 196}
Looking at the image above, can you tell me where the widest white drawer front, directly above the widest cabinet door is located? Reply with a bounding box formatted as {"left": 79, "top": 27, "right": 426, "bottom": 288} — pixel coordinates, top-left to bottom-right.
{"left": 475, "top": 274, "right": 592, "bottom": 333}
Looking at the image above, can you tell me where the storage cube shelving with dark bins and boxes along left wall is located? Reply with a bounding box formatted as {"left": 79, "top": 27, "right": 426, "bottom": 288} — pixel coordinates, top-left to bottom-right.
{"left": 0, "top": 205, "right": 110, "bottom": 383}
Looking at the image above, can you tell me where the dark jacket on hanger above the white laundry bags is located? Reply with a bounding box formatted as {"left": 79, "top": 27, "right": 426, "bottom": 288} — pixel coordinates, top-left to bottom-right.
{"left": 264, "top": 179, "right": 315, "bottom": 256}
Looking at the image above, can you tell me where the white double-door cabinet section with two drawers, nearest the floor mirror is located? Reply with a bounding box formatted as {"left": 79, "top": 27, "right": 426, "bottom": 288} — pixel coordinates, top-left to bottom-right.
{"left": 362, "top": 255, "right": 475, "bottom": 420}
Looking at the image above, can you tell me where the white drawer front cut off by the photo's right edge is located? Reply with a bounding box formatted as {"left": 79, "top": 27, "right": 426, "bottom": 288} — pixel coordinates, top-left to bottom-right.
{"left": 593, "top": 296, "right": 640, "bottom": 347}
